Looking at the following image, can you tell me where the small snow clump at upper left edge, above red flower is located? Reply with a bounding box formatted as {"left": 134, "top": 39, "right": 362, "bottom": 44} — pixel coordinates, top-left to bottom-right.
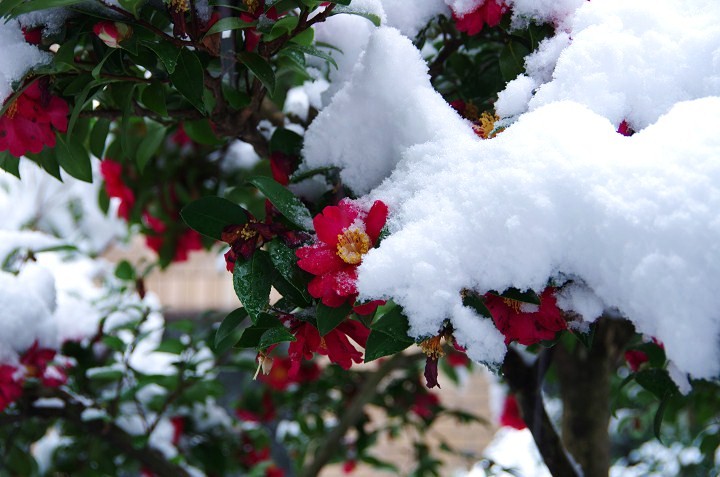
{"left": 0, "top": 20, "right": 49, "bottom": 103}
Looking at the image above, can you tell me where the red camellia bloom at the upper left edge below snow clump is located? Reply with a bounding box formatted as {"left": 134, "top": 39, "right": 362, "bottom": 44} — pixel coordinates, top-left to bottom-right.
{"left": 0, "top": 81, "right": 70, "bottom": 157}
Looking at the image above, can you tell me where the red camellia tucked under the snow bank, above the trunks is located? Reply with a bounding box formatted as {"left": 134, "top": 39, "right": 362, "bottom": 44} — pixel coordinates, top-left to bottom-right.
{"left": 485, "top": 287, "right": 567, "bottom": 346}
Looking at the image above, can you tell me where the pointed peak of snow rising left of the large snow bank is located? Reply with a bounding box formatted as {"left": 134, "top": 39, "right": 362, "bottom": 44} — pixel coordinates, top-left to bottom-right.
{"left": 303, "top": 28, "right": 464, "bottom": 194}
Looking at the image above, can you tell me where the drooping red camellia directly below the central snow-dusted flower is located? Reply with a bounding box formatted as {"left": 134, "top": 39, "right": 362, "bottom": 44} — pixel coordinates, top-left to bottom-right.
{"left": 285, "top": 316, "right": 370, "bottom": 377}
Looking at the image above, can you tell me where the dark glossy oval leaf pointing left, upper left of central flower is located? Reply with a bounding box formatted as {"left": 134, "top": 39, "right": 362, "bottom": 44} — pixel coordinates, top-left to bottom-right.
{"left": 180, "top": 196, "right": 248, "bottom": 240}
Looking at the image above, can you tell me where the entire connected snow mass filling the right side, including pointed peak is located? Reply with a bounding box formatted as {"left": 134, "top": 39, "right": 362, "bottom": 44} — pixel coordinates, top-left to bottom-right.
{"left": 304, "top": 0, "right": 720, "bottom": 378}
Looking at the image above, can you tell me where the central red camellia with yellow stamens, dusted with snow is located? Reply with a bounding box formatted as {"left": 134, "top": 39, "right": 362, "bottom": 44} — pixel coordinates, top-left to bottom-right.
{"left": 296, "top": 200, "right": 388, "bottom": 314}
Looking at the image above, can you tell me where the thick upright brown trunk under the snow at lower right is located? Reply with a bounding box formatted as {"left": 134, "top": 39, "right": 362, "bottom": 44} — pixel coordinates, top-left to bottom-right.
{"left": 554, "top": 318, "right": 633, "bottom": 477}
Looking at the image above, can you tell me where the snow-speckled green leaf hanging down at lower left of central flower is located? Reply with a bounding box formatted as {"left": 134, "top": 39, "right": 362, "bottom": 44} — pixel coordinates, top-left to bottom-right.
{"left": 233, "top": 250, "right": 274, "bottom": 323}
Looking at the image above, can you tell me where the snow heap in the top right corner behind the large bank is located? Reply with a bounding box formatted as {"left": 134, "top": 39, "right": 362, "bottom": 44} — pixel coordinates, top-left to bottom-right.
{"left": 501, "top": 0, "right": 720, "bottom": 130}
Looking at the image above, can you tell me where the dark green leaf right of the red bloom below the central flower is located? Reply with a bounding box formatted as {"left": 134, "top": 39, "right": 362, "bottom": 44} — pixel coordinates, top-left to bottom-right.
{"left": 365, "top": 306, "right": 415, "bottom": 363}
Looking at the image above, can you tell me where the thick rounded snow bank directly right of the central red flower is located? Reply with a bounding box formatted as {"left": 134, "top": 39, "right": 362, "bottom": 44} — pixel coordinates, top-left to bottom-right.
{"left": 359, "top": 98, "right": 720, "bottom": 378}
